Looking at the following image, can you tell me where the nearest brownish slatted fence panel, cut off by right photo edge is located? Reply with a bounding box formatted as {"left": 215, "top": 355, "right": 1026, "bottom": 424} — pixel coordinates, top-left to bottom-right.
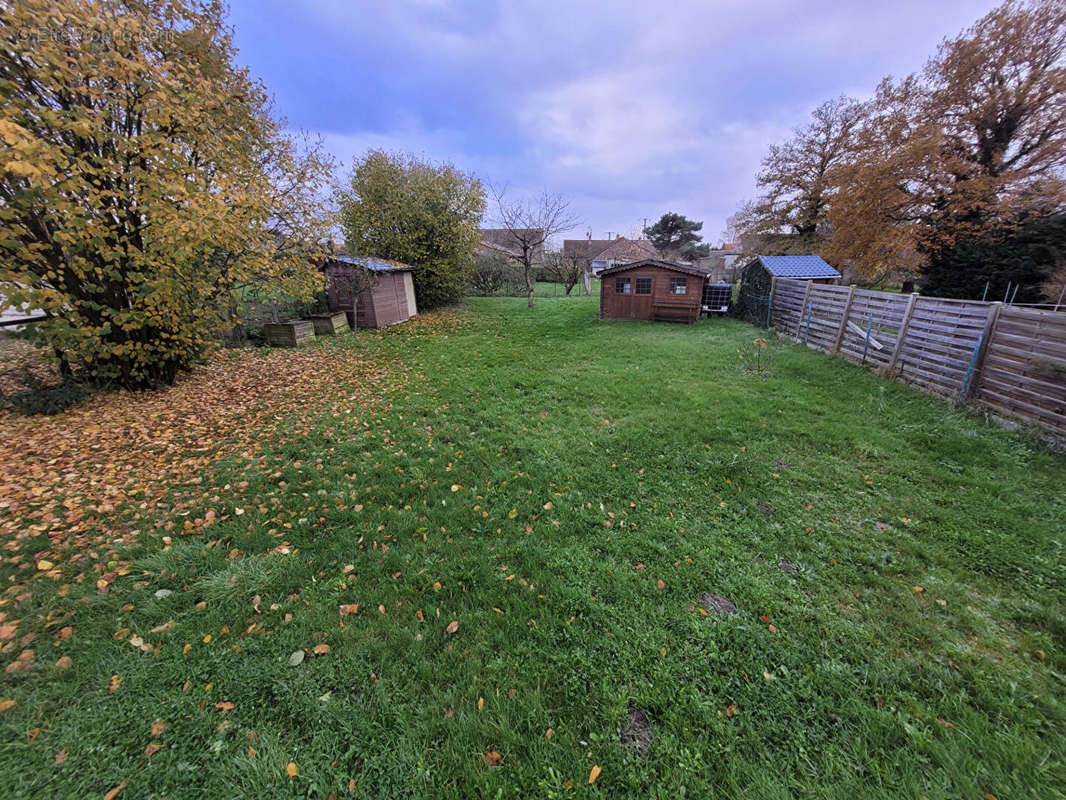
{"left": 974, "top": 306, "right": 1066, "bottom": 432}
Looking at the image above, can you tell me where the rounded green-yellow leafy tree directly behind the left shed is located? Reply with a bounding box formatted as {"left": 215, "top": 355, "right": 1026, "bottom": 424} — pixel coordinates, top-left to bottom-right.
{"left": 338, "top": 150, "right": 485, "bottom": 308}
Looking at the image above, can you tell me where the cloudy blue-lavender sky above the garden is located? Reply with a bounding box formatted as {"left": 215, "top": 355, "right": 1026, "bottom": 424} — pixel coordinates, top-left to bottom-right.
{"left": 231, "top": 0, "right": 998, "bottom": 243}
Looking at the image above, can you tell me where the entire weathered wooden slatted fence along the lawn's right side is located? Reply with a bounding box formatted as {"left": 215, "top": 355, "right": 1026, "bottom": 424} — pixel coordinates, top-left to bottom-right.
{"left": 770, "top": 278, "right": 1066, "bottom": 437}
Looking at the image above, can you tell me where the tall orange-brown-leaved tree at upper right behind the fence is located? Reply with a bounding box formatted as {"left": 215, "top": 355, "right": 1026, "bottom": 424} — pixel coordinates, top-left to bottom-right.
{"left": 824, "top": 0, "right": 1066, "bottom": 275}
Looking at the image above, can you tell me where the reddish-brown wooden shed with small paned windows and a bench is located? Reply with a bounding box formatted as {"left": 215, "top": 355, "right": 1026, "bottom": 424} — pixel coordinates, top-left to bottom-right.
{"left": 600, "top": 258, "right": 708, "bottom": 322}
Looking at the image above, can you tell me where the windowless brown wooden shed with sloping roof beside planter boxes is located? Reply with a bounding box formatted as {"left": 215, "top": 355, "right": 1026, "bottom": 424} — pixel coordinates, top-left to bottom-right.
{"left": 322, "top": 255, "right": 418, "bottom": 327}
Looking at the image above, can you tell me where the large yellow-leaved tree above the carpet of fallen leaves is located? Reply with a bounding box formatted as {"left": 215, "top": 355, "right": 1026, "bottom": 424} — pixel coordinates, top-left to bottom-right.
{"left": 0, "top": 0, "right": 332, "bottom": 388}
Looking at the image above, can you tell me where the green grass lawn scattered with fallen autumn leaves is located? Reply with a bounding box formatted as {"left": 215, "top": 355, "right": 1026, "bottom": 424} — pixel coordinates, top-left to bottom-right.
{"left": 0, "top": 295, "right": 1066, "bottom": 800}
